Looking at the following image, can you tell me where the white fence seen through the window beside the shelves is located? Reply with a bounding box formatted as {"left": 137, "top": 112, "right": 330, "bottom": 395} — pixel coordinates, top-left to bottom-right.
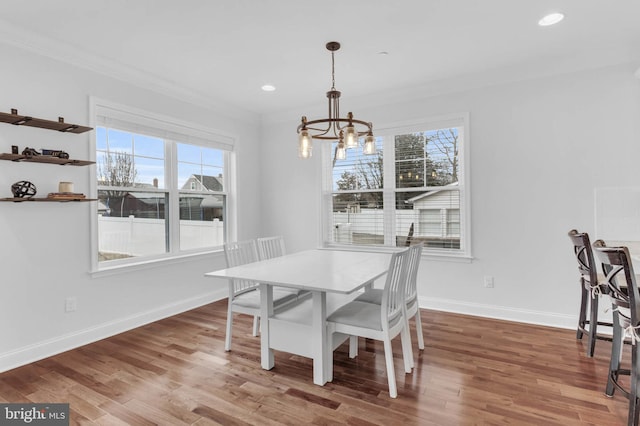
{"left": 98, "top": 216, "right": 224, "bottom": 256}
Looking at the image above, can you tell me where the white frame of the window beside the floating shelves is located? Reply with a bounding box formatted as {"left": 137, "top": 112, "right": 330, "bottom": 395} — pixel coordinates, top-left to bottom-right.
{"left": 89, "top": 97, "right": 237, "bottom": 276}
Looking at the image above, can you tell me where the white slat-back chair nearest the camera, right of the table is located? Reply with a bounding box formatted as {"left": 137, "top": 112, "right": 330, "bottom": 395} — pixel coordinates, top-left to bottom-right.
{"left": 327, "top": 249, "right": 411, "bottom": 398}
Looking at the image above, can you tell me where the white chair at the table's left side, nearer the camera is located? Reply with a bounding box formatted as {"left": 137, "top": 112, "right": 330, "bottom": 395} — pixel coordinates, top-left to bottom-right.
{"left": 224, "top": 240, "right": 298, "bottom": 351}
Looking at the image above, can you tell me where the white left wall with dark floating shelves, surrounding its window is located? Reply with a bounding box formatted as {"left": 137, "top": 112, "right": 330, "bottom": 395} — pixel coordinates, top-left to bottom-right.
{"left": 0, "top": 44, "right": 260, "bottom": 371}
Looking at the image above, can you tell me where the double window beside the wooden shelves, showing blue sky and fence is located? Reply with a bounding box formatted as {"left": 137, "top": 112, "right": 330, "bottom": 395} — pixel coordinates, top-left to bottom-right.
{"left": 94, "top": 101, "right": 233, "bottom": 270}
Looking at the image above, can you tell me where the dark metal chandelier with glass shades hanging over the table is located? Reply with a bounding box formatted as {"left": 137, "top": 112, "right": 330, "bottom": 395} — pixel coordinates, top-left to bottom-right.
{"left": 298, "top": 41, "right": 376, "bottom": 161}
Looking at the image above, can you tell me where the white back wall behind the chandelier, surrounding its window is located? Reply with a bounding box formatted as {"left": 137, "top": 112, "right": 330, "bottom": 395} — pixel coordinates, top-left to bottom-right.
{"left": 261, "top": 65, "right": 640, "bottom": 327}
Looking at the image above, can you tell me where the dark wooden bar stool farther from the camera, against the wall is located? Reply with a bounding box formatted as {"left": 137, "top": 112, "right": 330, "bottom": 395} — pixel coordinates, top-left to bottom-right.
{"left": 569, "top": 229, "right": 612, "bottom": 357}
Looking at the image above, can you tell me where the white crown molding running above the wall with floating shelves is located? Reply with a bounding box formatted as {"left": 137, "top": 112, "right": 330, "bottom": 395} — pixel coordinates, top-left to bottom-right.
{"left": 0, "top": 19, "right": 257, "bottom": 118}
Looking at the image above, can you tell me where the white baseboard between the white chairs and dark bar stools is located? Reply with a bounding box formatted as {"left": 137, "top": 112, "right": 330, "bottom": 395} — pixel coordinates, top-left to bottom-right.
{"left": 418, "top": 297, "right": 577, "bottom": 329}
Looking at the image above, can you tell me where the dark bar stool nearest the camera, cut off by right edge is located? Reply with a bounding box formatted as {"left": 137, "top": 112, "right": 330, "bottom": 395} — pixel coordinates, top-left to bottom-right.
{"left": 593, "top": 240, "right": 640, "bottom": 426}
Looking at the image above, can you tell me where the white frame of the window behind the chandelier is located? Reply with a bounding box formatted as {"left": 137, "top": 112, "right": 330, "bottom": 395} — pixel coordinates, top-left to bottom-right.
{"left": 320, "top": 112, "right": 473, "bottom": 261}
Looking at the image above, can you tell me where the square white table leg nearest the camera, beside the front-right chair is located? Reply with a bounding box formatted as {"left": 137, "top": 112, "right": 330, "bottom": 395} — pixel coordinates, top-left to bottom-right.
{"left": 311, "top": 291, "right": 328, "bottom": 386}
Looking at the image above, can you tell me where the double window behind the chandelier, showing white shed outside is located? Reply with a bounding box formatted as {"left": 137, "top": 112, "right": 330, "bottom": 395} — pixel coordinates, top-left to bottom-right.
{"left": 323, "top": 115, "right": 470, "bottom": 256}
